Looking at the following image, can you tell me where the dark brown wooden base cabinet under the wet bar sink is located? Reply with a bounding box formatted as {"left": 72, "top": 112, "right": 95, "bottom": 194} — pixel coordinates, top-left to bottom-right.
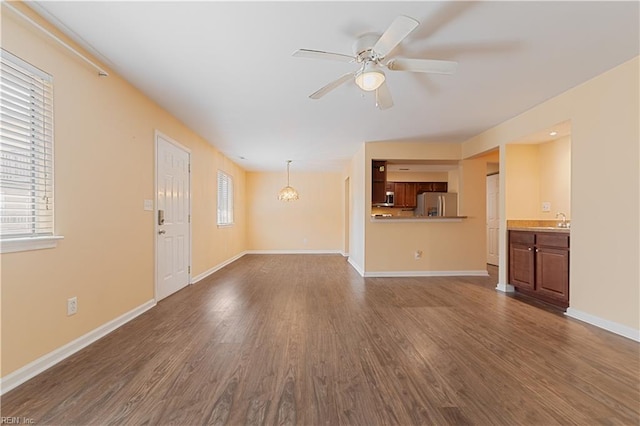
{"left": 509, "top": 231, "right": 569, "bottom": 308}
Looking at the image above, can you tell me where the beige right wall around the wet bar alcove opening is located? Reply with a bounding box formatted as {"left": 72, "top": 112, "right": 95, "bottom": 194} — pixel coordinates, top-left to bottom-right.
{"left": 462, "top": 57, "right": 640, "bottom": 331}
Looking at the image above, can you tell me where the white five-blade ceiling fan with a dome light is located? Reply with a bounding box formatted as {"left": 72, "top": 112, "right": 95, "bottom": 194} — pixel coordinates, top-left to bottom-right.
{"left": 293, "top": 15, "right": 458, "bottom": 109}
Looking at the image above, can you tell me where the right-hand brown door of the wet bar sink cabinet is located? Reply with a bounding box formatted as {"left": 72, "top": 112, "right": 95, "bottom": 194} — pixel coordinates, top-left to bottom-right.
{"left": 536, "top": 247, "right": 569, "bottom": 303}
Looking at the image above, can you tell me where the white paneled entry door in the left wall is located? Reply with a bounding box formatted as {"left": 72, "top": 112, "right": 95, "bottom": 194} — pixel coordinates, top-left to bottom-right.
{"left": 155, "top": 133, "right": 191, "bottom": 300}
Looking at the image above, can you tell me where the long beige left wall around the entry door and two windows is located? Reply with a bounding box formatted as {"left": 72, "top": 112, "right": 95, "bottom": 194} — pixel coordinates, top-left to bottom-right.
{"left": 1, "top": 4, "right": 246, "bottom": 377}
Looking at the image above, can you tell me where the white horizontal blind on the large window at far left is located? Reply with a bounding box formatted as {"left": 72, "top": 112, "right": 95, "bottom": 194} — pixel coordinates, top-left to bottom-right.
{"left": 0, "top": 50, "right": 53, "bottom": 239}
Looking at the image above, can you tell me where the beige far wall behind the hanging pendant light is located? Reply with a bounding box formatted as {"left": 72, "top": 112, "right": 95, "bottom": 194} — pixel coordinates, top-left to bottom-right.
{"left": 247, "top": 168, "right": 344, "bottom": 252}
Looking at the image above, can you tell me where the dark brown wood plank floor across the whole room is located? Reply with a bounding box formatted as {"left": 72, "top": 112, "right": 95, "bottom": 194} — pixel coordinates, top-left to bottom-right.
{"left": 2, "top": 255, "right": 640, "bottom": 425}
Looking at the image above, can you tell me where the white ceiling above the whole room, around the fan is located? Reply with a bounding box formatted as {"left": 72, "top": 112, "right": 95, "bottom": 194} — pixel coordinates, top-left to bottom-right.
{"left": 30, "top": 1, "right": 639, "bottom": 171}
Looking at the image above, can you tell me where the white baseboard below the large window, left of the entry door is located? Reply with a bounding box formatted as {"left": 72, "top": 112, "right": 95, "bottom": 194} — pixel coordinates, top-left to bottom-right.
{"left": 0, "top": 299, "right": 156, "bottom": 395}
